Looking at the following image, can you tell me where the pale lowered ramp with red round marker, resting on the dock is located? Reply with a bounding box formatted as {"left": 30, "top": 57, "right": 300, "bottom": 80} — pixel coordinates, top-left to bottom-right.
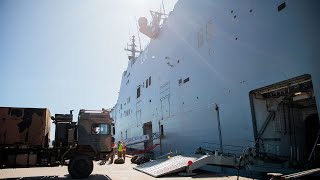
{"left": 133, "top": 154, "right": 237, "bottom": 177}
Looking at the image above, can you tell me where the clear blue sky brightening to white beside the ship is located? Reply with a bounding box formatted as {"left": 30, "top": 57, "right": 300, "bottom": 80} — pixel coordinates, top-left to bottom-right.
{"left": 0, "top": 0, "right": 176, "bottom": 139}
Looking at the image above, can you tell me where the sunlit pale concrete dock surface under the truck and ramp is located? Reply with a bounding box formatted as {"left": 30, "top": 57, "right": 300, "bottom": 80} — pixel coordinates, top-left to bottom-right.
{"left": 0, "top": 158, "right": 249, "bottom": 180}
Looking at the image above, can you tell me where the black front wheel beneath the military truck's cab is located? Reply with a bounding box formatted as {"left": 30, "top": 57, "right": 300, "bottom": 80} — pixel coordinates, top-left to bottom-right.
{"left": 68, "top": 155, "right": 93, "bottom": 179}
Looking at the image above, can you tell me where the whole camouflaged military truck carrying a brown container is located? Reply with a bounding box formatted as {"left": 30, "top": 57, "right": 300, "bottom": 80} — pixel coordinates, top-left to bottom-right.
{"left": 0, "top": 107, "right": 115, "bottom": 178}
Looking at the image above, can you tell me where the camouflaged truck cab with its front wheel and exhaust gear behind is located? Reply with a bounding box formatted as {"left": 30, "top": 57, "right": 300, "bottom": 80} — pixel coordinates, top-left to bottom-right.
{"left": 52, "top": 109, "right": 114, "bottom": 178}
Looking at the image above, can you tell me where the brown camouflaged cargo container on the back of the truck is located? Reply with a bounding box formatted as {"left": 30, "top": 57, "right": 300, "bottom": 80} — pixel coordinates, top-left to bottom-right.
{"left": 0, "top": 107, "right": 51, "bottom": 147}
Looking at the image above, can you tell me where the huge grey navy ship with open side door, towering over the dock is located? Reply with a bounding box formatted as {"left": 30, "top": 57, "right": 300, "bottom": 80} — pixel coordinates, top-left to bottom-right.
{"left": 112, "top": 0, "right": 320, "bottom": 175}
